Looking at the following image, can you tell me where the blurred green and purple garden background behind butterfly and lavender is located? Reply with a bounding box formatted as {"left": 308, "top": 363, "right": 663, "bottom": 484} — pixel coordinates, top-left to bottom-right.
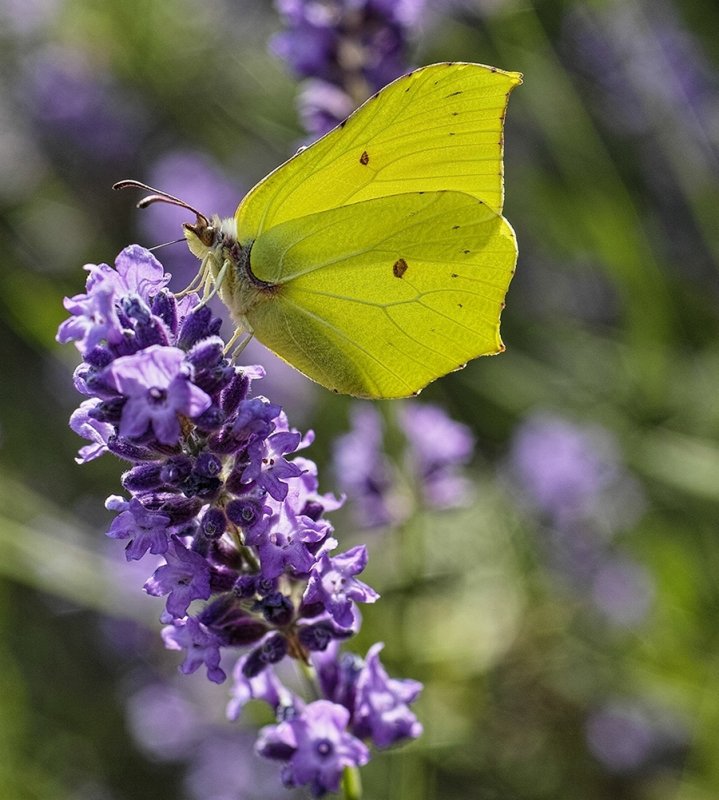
{"left": 0, "top": 0, "right": 719, "bottom": 800}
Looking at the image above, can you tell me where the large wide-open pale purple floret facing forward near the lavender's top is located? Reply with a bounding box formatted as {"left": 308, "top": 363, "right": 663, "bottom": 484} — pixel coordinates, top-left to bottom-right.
{"left": 105, "top": 345, "right": 212, "bottom": 444}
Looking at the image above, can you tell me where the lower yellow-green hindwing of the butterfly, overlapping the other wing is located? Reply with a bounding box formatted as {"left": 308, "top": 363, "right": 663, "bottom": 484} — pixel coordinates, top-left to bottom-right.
{"left": 248, "top": 191, "right": 517, "bottom": 398}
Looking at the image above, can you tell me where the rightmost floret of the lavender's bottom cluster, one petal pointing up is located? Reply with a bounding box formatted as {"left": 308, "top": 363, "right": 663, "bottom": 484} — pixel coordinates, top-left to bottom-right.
{"left": 352, "top": 643, "right": 422, "bottom": 747}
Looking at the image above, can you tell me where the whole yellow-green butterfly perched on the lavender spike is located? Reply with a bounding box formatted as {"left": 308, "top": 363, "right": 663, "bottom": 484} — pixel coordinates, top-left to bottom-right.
{"left": 122, "top": 63, "right": 521, "bottom": 399}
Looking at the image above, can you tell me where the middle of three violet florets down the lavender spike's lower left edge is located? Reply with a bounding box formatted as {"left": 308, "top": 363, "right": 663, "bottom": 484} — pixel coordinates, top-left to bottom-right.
{"left": 144, "top": 534, "right": 212, "bottom": 619}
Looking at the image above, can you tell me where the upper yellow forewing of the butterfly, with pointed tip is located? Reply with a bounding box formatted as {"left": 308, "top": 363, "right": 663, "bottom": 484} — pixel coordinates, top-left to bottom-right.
{"left": 235, "top": 63, "right": 521, "bottom": 244}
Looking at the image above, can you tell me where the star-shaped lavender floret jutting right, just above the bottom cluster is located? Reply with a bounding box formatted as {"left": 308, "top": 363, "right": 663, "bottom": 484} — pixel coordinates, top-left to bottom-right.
{"left": 303, "top": 545, "right": 379, "bottom": 628}
